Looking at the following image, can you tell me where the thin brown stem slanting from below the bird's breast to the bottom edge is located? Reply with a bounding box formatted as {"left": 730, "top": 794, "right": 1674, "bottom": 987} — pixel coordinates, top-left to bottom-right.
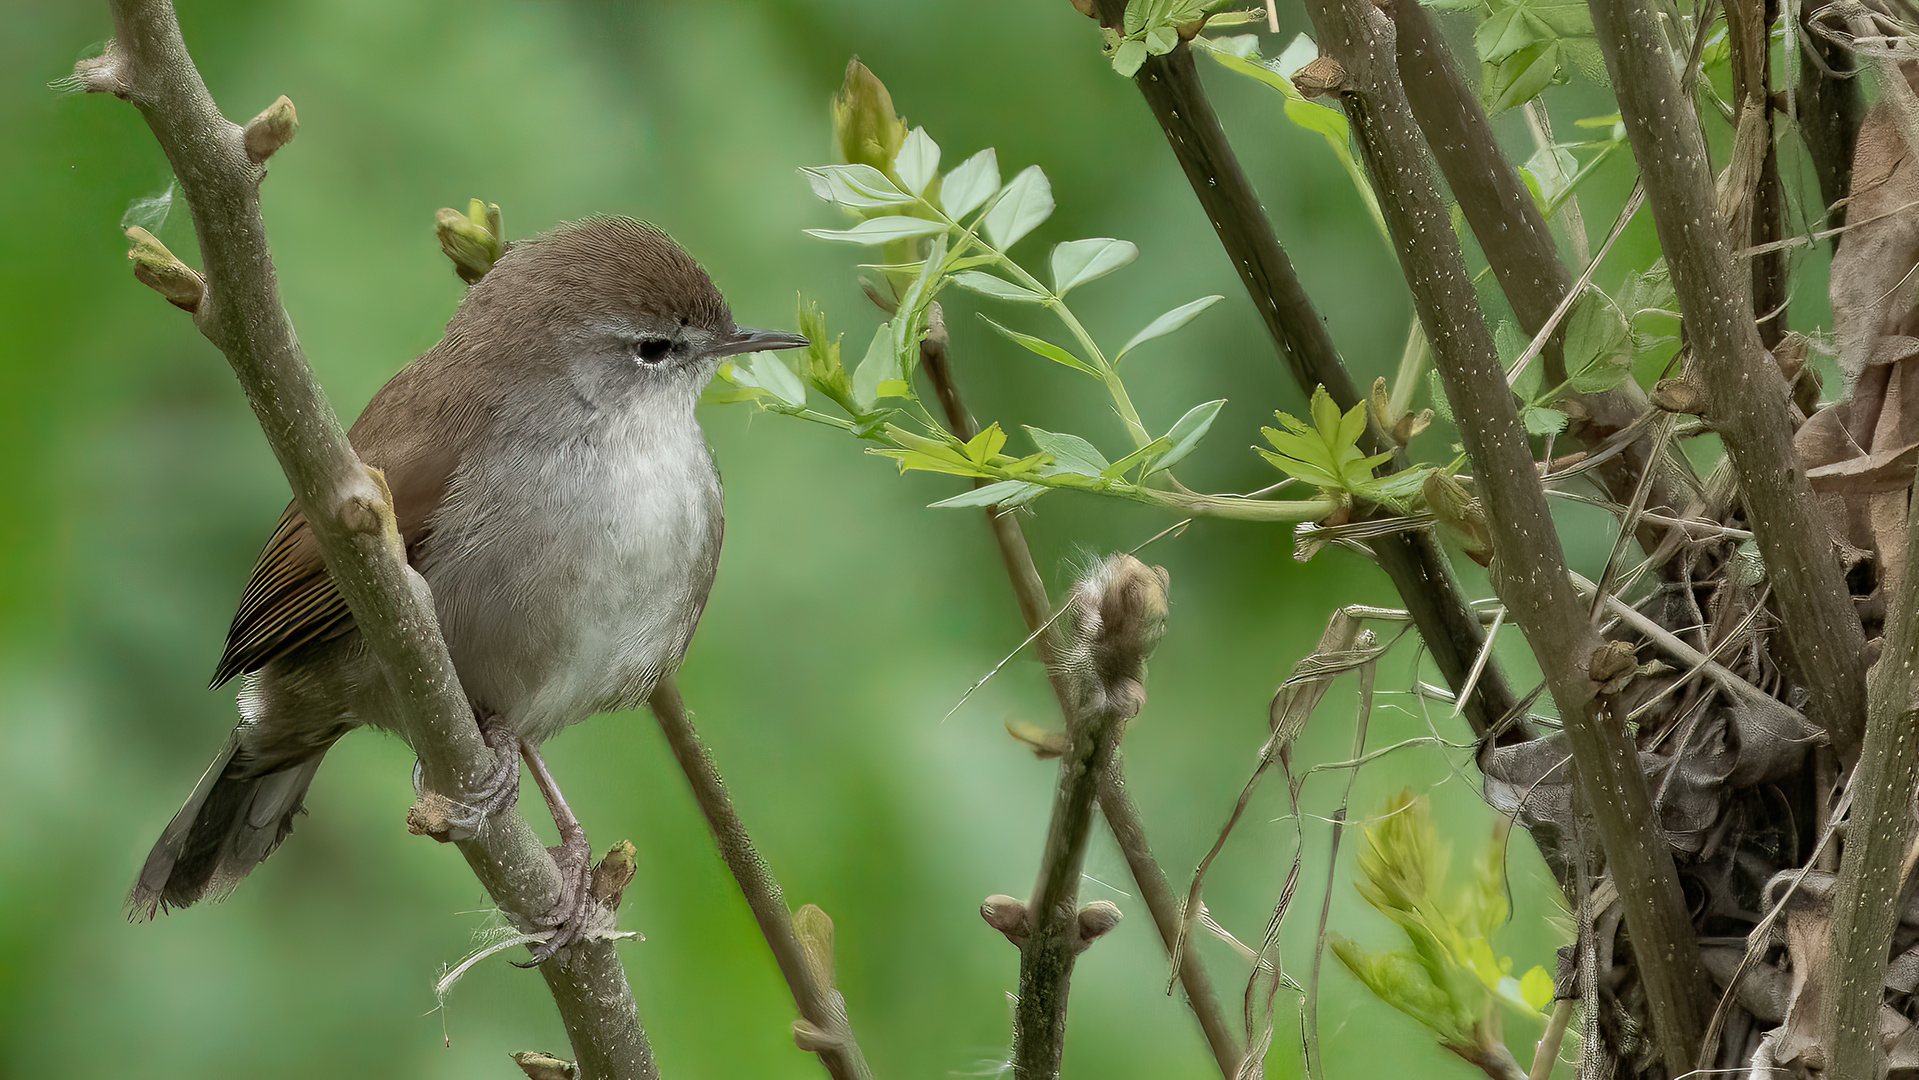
{"left": 647, "top": 675, "right": 873, "bottom": 1080}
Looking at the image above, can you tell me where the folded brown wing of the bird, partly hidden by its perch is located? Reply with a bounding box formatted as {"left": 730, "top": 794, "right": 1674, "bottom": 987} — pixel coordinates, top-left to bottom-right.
{"left": 213, "top": 435, "right": 459, "bottom": 687}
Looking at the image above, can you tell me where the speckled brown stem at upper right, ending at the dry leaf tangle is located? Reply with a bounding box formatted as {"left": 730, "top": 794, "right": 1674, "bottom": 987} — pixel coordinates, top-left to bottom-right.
{"left": 1591, "top": 0, "right": 1865, "bottom": 762}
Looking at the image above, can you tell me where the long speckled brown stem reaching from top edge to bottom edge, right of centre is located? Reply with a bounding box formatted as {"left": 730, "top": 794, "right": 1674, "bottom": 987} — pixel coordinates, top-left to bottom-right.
{"left": 1307, "top": 0, "right": 1719, "bottom": 1076}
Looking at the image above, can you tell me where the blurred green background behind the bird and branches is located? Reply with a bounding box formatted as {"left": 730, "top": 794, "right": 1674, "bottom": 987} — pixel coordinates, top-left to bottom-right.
{"left": 0, "top": 0, "right": 1588, "bottom": 1078}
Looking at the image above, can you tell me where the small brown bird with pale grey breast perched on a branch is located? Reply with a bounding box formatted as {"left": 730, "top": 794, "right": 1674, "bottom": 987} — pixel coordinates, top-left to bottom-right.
{"left": 127, "top": 217, "right": 806, "bottom": 959}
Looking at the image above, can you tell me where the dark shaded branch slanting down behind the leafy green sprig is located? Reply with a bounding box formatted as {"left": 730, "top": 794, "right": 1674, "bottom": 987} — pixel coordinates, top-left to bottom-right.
{"left": 1096, "top": 0, "right": 1528, "bottom": 744}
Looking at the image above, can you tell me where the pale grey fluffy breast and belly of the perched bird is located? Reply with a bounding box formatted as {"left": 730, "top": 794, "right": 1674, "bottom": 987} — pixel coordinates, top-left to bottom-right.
{"left": 416, "top": 399, "right": 722, "bottom": 742}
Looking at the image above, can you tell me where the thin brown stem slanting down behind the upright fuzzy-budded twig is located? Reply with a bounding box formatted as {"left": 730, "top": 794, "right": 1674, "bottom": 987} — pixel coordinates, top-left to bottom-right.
{"left": 919, "top": 314, "right": 1244, "bottom": 1080}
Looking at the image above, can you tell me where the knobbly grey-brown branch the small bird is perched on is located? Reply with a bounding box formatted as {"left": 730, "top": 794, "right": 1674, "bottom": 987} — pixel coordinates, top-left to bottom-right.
{"left": 75, "top": 0, "right": 658, "bottom": 1078}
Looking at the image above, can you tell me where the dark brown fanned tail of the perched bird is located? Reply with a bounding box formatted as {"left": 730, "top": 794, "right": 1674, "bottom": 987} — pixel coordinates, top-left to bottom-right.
{"left": 127, "top": 727, "right": 332, "bottom": 921}
